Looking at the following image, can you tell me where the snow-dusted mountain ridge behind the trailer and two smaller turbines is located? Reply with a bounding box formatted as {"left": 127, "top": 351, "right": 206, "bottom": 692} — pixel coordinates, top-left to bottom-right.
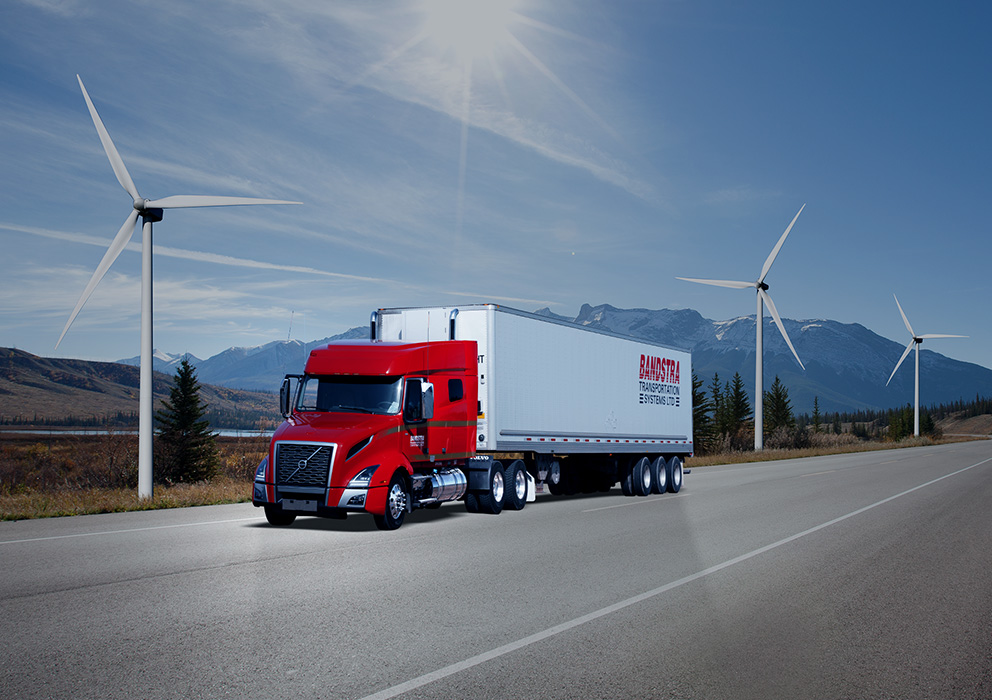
{"left": 538, "top": 304, "right": 992, "bottom": 413}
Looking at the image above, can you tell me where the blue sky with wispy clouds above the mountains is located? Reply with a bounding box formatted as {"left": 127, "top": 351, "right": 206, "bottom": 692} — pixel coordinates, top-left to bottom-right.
{"left": 0, "top": 0, "right": 992, "bottom": 378}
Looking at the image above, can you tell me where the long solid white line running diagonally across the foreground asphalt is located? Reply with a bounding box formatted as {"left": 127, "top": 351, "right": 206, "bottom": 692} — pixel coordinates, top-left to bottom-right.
{"left": 361, "top": 457, "right": 992, "bottom": 700}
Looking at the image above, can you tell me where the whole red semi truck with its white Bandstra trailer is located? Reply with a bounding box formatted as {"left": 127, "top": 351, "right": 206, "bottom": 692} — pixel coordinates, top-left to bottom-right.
{"left": 252, "top": 304, "right": 692, "bottom": 530}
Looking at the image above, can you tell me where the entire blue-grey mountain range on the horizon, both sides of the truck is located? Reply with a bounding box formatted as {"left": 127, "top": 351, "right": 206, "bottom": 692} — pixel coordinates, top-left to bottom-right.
{"left": 120, "top": 304, "right": 992, "bottom": 413}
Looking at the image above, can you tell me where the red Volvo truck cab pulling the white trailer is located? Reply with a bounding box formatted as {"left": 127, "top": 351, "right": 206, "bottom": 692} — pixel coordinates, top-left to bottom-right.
{"left": 252, "top": 340, "right": 478, "bottom": 529}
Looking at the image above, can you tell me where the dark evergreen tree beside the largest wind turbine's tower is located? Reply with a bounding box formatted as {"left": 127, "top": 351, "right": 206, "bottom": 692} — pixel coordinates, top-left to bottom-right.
{"left": 155, "top": 357, "right": 219, "bottom": 483}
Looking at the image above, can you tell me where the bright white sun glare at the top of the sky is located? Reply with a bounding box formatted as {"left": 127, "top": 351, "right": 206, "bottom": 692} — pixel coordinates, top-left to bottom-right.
{"left": 424, "top": 0, "right": 517, "bottom": 62}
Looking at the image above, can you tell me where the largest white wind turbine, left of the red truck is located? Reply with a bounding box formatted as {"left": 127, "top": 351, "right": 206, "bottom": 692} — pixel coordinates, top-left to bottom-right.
{"left": 55, "top": 75, "right": 300, "bottom": 498}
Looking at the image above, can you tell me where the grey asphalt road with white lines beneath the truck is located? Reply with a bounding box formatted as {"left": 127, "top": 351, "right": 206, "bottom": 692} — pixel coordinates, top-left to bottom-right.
{"left": 0, "top": 441, "right": 992, "bottom": 700}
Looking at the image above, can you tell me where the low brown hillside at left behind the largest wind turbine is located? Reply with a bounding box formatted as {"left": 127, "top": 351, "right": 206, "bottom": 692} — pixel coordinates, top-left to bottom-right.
{"left": 0, "top": 348, "right": 281, "bottom": 429}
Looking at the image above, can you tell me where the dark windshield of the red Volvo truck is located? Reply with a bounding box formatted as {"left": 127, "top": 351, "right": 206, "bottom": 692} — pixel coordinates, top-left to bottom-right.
{"left": 296, "top": 375, "right": 401, "bottom": 414}
